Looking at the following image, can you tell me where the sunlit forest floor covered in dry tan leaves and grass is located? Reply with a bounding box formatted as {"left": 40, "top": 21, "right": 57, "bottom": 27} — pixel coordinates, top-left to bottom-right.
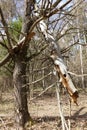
{"left": 0, "top": 91, "right": 87, "bottom": 130}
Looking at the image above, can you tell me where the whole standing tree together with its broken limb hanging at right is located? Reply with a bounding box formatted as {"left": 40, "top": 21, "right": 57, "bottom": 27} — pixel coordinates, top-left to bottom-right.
{"left": 0, "top": 0, "right": 78, "bottom": 127}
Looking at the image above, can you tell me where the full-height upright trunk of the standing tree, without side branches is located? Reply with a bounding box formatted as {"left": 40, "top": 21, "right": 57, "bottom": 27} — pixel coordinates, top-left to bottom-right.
{"left": 13, "top": 0, "right": 34, "bottom": 128}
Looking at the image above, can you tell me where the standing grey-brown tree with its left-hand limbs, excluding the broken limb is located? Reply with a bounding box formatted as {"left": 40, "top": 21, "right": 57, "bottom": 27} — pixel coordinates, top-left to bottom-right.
{"left": 0, "top": 1, "right": 33, "bottom": 127}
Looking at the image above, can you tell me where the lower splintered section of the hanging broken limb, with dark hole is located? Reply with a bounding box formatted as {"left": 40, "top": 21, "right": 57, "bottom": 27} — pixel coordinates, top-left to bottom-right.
{"left": 51, "top": 55, "right": 78, "bottom": 105}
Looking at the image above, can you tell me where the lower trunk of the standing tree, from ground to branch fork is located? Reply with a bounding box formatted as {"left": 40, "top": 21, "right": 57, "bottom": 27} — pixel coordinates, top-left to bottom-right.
{"left": 13, "top": 51, "right": 31, "bottom": 127}
